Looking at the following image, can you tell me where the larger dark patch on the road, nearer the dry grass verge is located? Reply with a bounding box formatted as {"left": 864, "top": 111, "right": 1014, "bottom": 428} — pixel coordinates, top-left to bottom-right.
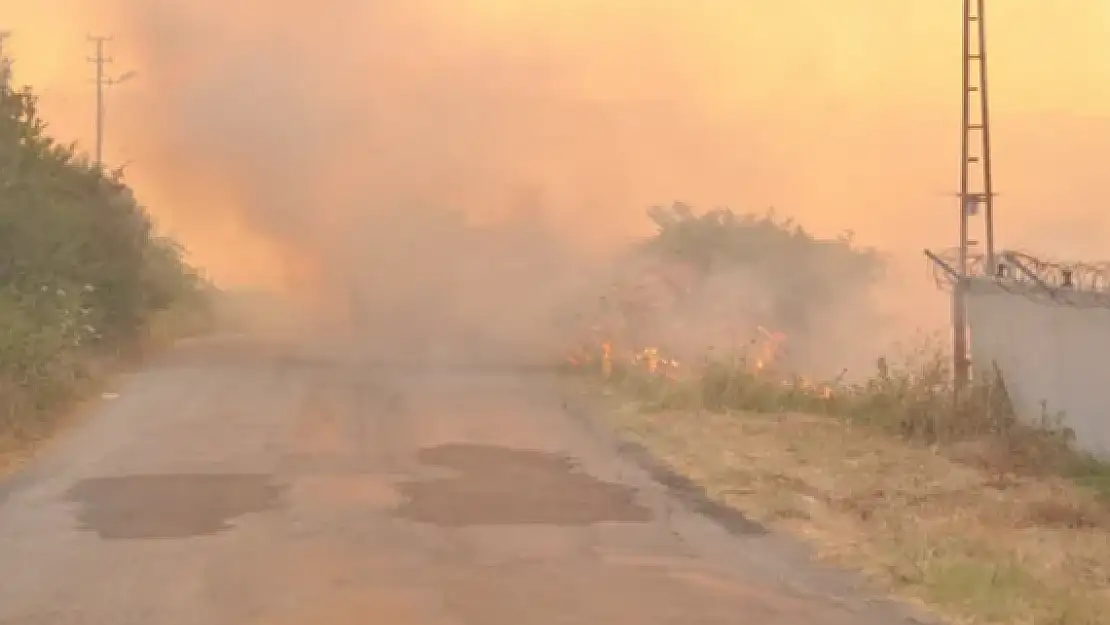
{"left": 395, "top": 444, "right": 650, "bottom": 527}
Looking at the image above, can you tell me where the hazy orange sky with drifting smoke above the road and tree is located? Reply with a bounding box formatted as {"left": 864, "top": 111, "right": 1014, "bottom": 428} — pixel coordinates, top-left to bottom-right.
{"left": 0, "top": 0, "right": 1110, "bottom": 293}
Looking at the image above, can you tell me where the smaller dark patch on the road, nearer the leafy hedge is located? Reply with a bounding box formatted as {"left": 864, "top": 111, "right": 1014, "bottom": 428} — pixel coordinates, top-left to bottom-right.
{"left": 70, "top": 474, "right": 284, "bottom": 540}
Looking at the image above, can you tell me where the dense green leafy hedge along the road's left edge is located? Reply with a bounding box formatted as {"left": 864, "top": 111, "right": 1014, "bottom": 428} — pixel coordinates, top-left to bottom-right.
{"left": 0, "top": 79, "right": 205, "bottom": 433}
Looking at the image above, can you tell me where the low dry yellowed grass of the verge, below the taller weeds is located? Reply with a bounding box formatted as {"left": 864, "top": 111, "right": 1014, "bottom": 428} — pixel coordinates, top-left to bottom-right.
{"left": 577, "top": 357, "right": 1110, "bottom": 625}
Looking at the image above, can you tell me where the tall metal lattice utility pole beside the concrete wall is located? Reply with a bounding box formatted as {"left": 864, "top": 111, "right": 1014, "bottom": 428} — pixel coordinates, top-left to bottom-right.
{"left": 952, "top": 0, "right": 997, "bottom": 387}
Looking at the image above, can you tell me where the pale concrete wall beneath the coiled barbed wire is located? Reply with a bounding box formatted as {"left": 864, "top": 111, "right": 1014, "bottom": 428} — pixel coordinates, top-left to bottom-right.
{"left": 968, "top": 281, "right": 1110, "bottom": 457}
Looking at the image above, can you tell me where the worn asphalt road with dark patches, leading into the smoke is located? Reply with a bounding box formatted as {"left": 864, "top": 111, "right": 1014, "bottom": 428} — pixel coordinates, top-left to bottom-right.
{"left": 0, "top": 343, "right": 927, "bottom": 625}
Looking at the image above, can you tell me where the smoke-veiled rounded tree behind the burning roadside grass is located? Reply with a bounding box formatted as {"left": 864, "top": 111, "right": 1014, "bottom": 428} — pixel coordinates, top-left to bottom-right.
{"left": 599, "top": 203, "right": 885, "bottom": 366}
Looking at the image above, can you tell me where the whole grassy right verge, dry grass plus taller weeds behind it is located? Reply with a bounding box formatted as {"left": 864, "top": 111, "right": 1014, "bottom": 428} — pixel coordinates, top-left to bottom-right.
{"left": 575, "top": 346, "right": 1110, "bottom": 625}
